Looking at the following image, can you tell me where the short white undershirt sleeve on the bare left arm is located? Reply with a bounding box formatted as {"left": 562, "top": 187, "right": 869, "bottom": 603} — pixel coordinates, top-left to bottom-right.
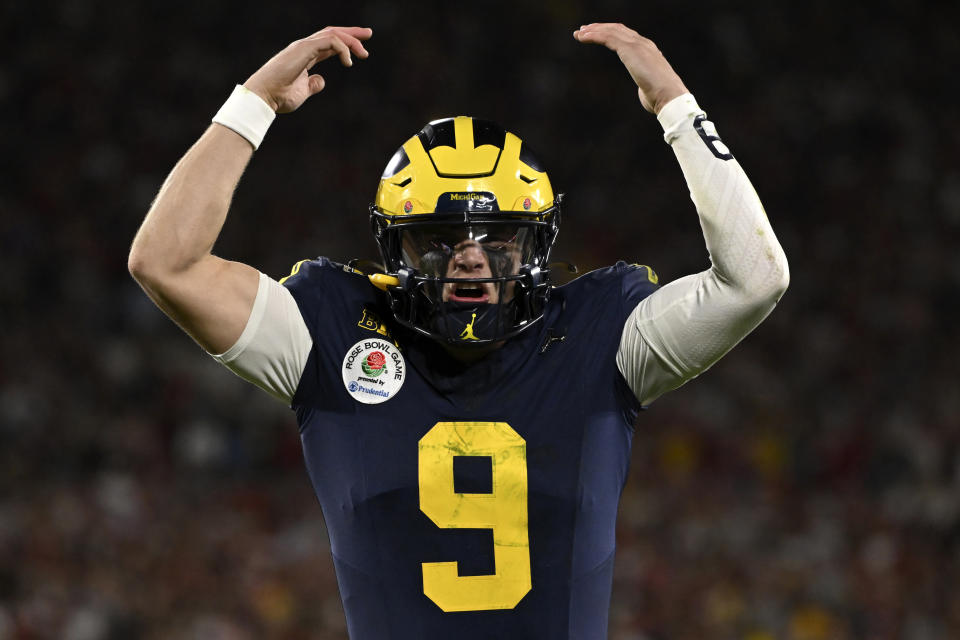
{"left": 211, "top": 273, "right": 313, "bottom": 403}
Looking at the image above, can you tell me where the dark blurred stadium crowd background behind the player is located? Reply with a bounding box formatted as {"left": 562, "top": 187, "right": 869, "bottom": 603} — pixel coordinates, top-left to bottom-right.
{"left": 0, "top": 0, "right": 960, "bottom": 640}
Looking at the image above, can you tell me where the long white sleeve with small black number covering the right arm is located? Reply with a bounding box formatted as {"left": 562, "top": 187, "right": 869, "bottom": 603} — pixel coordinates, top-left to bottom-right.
{"left": 617, "top": 94, "right": 790, "bottom": 405}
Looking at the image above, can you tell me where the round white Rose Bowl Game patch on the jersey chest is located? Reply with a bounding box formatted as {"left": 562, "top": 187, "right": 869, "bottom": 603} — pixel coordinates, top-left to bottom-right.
{"left": 342, "top": 338, "right": 407, "bottom": 404}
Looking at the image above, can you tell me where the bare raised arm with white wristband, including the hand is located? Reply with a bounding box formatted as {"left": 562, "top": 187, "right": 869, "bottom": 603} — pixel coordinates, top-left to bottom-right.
{"left": 128, "top": 27, "right": 372, "bottom": 353}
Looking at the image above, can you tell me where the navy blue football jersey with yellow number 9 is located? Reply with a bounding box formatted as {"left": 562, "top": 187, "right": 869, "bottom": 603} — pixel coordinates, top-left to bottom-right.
{"left": 284, "top": 259, "right": 656, "bottom": 640}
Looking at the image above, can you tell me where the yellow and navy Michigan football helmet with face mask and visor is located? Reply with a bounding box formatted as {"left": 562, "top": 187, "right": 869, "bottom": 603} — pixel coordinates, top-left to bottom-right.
{"left": 370, "top": 116, "right": 562, "bottom": 347}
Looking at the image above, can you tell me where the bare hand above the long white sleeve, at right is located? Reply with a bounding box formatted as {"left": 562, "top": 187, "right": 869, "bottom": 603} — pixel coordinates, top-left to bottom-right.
{"left": 573, "top": 22, "right": 687, "bottom": 114}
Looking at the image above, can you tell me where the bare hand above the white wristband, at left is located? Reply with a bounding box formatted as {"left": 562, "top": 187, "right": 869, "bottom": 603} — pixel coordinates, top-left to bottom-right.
{"left": 243, "top": 27, "right": 373, "bottom": 113}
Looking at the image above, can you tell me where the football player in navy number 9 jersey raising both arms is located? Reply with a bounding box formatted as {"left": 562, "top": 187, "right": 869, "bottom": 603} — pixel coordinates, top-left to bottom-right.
{"left": 129, "top": 24, "right": 788, "bottom": 640}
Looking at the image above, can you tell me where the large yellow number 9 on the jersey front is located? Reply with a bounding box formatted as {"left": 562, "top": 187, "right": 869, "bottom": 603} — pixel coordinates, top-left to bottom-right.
{"left": 419, "top": 422, "right": 530, "bottom": 611}
